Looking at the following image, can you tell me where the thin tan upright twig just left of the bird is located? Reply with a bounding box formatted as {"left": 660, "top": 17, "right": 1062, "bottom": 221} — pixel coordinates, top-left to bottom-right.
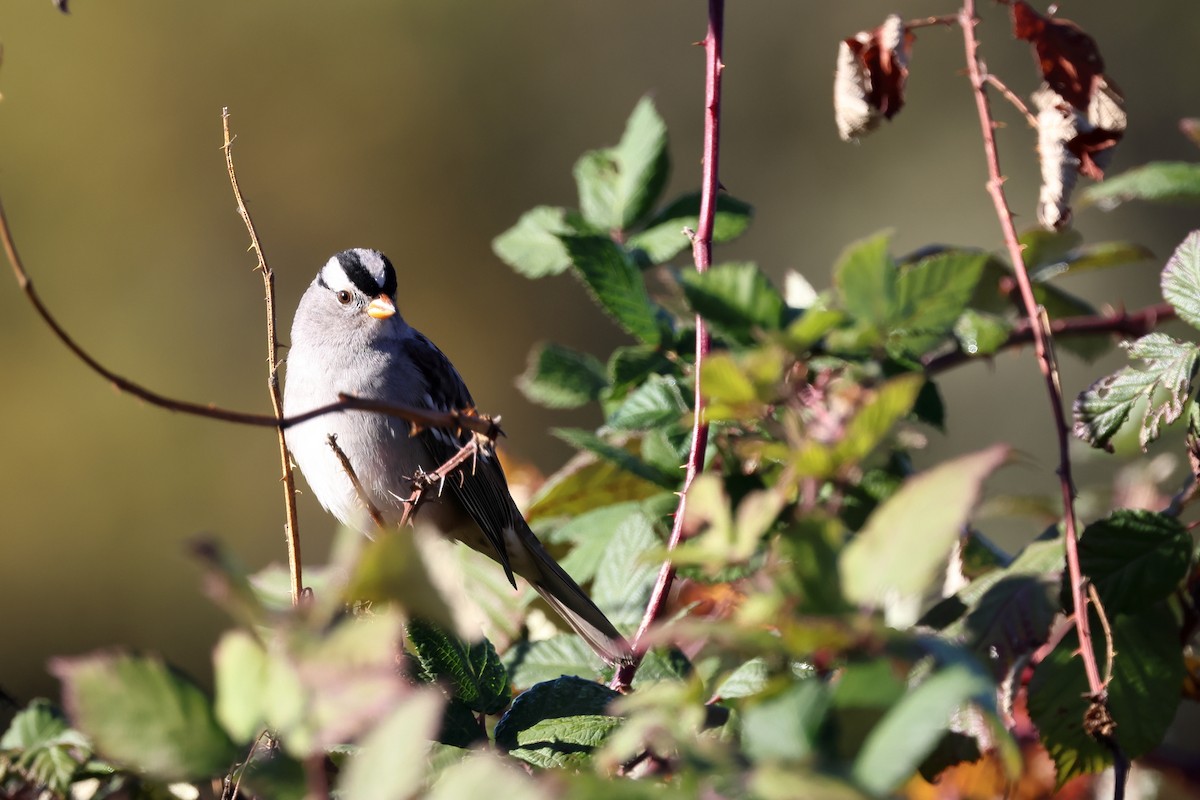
{"left": 221, "top": 108, "right": 304, "bottom": 606}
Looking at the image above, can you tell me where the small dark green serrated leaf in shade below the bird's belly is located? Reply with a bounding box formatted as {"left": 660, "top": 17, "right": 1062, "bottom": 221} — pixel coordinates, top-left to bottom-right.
{"left": 407, "top": 619, "right": 511, "bottom": 714}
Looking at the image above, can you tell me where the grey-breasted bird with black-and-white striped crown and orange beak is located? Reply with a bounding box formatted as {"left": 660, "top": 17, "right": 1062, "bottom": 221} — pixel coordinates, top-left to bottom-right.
{"left": 283, "top": 248, "right": 631, "bottom": 664}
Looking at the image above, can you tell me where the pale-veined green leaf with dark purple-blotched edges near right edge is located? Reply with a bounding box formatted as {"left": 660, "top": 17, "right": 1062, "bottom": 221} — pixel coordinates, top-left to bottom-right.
{"left": 1074, "top": 333, "right": 1200, "bottom": 452}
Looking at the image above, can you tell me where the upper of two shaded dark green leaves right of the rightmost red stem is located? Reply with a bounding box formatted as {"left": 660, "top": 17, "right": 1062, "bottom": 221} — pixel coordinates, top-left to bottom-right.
{"left": 1079, "top": 509, "right": 1192, "bottom": 614}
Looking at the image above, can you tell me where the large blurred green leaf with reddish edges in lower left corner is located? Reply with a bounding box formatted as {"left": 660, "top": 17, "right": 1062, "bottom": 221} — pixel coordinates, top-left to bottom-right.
{"left": 50, "top": 652, "right": 239, "bottom": 782}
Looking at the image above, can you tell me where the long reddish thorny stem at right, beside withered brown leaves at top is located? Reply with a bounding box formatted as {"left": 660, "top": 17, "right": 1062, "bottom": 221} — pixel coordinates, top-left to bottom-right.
{"left": 959, "top": 0, "right": 1105, "bottom": 719}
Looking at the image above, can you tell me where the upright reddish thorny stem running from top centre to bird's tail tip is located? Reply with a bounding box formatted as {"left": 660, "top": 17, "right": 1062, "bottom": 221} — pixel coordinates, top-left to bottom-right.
{"left": 612, "top": 0, "right": 725, "bottom": 691}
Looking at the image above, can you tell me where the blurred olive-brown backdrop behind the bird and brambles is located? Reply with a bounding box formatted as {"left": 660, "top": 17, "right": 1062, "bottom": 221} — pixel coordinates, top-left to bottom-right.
{"left": 0, "top": 0, "right": 1200, "bottom": 698}
